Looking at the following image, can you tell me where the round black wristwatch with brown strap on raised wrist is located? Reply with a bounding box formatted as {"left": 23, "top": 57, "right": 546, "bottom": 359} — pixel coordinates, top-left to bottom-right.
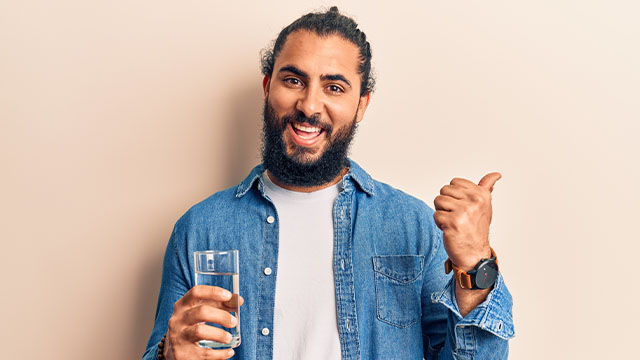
{"left": 444, "top": 249, "right": 498, "bottom": 290}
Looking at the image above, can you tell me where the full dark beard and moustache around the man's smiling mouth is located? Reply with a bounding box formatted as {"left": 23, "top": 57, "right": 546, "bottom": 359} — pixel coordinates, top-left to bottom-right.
{"left": 262, "top": 98, "right": 358, "bottom": 187}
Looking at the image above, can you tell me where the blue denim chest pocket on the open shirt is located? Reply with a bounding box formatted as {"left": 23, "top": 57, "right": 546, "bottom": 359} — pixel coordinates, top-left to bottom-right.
{"left": 373, "top": 255, "right": 424, "bottom": 328}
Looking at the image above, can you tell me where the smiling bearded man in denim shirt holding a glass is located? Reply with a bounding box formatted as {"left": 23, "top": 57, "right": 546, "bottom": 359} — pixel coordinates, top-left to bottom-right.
{"left": 144, "top": 7, "right": 513, "bottom": 360}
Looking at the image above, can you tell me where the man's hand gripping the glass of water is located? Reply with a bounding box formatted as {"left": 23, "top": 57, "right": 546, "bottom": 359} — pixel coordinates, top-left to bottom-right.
{"left": 164, "top": 285, "right": 244, "bottom": 360}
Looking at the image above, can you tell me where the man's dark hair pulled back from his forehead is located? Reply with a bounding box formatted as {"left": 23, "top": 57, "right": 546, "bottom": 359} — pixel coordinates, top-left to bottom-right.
{"left": 261, "top": 6, "right": 375, "bottom": 96}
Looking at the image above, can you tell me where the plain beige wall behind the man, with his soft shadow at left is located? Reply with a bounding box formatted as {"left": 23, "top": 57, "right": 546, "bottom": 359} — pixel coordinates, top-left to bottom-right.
{"left": 0, "top": 0, "right": 640, "bottom": 360}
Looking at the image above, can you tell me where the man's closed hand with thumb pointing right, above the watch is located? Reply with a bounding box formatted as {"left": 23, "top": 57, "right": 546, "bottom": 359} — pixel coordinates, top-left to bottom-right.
{"left": 433, "top": 172, "right": 502, "bottom": 271}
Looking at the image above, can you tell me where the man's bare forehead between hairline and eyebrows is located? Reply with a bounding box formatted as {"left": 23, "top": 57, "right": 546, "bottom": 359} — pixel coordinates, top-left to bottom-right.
{"left": 274, "top": 30, "right": 360, "bottom": 80}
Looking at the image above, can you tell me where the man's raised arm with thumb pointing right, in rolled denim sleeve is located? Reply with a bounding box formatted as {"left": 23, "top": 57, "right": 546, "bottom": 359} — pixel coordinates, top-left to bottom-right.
{"left": 423, "top": 173, "right": 513, "bottom": 359}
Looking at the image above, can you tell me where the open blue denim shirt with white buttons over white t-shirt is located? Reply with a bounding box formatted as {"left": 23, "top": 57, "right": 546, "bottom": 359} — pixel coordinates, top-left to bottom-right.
{"left": 143, "top": 161, "right": 514, "bottom": 360}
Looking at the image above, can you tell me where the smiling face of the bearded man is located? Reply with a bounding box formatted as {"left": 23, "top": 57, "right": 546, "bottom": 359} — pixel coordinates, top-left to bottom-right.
{"left": 264, "top": 31, "right": 369, "bottom": 185}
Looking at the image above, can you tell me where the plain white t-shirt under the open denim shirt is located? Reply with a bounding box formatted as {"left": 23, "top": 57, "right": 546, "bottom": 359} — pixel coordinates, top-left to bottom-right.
{"left": 262, "top": 171, "right": 341, "bottom": 360}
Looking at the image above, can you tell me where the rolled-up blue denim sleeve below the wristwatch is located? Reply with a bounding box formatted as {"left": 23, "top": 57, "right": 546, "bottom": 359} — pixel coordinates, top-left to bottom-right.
{"left": 422, "top": 224, "right": 515, "bottom": 360}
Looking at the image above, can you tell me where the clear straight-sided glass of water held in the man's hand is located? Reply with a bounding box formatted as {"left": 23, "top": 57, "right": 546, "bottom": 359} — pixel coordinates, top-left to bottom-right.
{"left": 193, "top": 250, "right": 240, "bottom": 349}
